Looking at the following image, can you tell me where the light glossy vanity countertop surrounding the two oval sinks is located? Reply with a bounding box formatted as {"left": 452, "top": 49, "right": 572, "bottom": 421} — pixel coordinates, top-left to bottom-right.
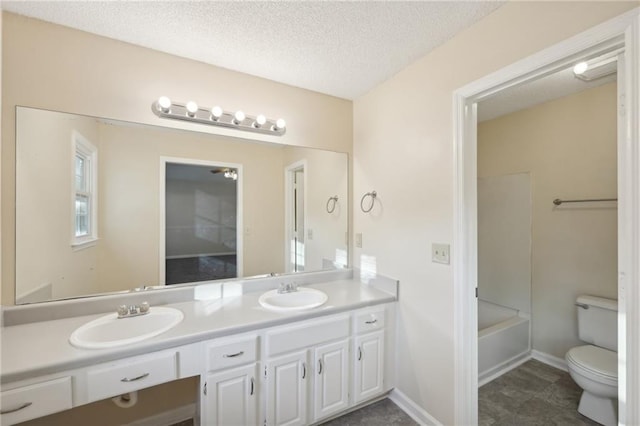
{"left": 0, "top": 279, "right": 396, "bottom": 384}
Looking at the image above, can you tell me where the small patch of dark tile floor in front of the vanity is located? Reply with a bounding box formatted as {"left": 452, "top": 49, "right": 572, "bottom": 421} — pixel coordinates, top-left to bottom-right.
{"left": 322, "top": 398, "right": 418, "bottom": 426}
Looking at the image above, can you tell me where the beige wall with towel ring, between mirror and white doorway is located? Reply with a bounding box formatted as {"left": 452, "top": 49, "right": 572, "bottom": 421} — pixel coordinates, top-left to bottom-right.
{"left": 353, "top": 2, "right": 637, "bottom": 424}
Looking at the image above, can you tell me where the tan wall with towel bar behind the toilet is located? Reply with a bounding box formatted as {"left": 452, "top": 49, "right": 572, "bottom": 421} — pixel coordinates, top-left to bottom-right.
{"left": 478, "top": 83, "right": 618, "bottom": 358}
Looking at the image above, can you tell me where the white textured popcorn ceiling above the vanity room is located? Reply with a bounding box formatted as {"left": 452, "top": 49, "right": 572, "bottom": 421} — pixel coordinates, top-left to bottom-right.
{"left": 2, "top": 0, "right": 503, "bottom": 99}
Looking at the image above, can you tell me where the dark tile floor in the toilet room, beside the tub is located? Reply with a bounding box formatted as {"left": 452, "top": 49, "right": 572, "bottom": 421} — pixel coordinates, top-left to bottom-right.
{"left": 478, "top": 360, "right": 598, "bottom": 426}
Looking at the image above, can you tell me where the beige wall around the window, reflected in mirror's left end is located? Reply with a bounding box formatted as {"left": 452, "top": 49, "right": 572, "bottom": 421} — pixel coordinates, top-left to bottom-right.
{"left": 16, "top": 109, "right": 100, "bottom": 303}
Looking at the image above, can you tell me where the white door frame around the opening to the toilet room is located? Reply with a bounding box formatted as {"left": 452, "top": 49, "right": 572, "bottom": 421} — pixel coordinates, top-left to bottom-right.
{"left": 453, "top": 8, "right": 640, "bottom": 424}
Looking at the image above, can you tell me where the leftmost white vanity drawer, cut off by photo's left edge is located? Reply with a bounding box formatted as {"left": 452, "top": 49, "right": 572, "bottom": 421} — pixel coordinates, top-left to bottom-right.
{"left": 0, "top": 377, "right": 72, "bottom": 425}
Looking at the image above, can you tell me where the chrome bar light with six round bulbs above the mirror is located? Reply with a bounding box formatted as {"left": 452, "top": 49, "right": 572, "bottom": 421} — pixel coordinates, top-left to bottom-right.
{"left": 151, "top": 96, "right": 287, "bottom": 136}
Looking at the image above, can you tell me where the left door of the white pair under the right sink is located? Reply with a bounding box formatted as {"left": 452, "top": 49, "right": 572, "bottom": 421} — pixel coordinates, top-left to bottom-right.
{"left": 267, "top": 351, "right": 310, "bottom": 426}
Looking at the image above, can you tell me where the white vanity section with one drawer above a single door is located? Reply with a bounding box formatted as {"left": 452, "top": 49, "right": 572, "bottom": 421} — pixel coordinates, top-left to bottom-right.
{"left": 201, "top": 334, "right": 260, "bottom": 426}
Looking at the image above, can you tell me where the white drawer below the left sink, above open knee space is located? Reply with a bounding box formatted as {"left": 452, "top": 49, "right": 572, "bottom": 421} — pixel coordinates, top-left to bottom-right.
{"left": 87, "top": 352, "right": 178, "bottom": 402}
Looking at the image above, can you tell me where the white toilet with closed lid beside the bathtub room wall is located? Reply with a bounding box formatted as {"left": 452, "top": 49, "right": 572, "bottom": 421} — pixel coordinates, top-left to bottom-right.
{"left": 565, "top": 296, "right": 618, "bottom": 426}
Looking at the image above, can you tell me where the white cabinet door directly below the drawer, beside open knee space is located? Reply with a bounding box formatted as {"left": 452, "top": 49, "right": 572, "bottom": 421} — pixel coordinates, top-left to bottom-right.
{"left": 203, "top": 363, "right": 258, "bottom": 426}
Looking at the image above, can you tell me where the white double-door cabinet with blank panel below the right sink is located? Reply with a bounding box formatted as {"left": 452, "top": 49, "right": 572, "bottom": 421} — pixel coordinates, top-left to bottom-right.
{"left": 264, "top": 314, "right": 351, "bottom": 426}
